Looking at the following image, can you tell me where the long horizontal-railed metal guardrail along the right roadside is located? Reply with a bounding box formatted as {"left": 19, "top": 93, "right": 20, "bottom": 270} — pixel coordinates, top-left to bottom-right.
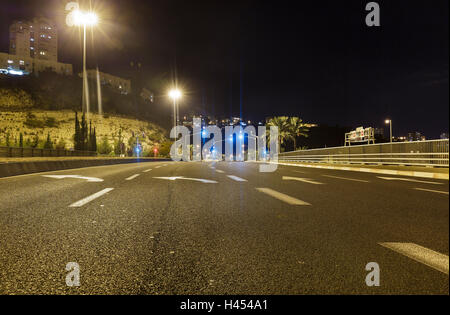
{"left": 278, "top": 139, "right": 449, "bottom": 167}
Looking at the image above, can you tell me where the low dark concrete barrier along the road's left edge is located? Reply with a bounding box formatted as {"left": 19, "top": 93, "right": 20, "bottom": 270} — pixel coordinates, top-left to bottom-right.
{"left": 0, "top": 158, "right": 171, "bottom": 177}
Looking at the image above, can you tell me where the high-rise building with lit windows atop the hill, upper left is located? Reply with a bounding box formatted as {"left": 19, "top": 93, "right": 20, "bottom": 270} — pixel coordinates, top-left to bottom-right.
{"left": 9, "top": 17, "right": 58, "bottom": 62}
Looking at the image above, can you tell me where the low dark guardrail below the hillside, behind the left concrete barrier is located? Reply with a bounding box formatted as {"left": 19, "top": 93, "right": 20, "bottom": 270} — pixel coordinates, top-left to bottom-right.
{"left": 0, "top": 147, "right": 97, "bottom": 157}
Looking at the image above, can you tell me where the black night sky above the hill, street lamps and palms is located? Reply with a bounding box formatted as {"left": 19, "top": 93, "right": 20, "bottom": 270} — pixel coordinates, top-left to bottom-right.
{"left": 0, "top": 0, "right": 449, "bottom": 138}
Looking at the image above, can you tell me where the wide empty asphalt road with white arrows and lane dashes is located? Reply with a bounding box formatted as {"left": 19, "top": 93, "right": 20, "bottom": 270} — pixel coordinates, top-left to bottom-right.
{"left": 0, "top": 162, "right": 449, "bottom": 294}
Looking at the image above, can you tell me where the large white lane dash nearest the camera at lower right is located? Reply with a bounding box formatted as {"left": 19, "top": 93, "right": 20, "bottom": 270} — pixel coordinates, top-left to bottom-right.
{"left": 379, "top": 243, "right": 449, "bottom": 275}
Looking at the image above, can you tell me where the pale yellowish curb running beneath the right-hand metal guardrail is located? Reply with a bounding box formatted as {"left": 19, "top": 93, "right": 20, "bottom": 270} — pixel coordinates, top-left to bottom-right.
{"left": 276, "top": 162, "right": 449, "bottom": 180}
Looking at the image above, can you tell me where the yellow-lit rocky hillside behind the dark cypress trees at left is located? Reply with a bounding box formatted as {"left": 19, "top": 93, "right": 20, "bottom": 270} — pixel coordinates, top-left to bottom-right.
{"left": 0, "top": 109, "right": 167, "bottom": 156}
